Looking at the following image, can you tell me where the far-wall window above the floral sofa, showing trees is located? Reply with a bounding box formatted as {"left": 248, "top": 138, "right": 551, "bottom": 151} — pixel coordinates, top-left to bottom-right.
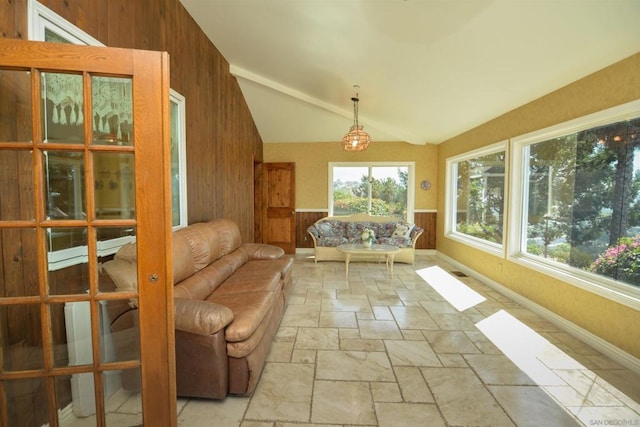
{"left": 329, "top": 162, "right": 415, "bottom": 222}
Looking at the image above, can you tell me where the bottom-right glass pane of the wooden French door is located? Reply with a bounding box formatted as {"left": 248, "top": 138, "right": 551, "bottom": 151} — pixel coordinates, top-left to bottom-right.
{"left": 104, "top": 369, "right": 142, "bottom": 426}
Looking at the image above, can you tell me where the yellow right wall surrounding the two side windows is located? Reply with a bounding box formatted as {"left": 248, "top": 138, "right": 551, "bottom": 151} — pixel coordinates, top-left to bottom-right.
{"left": 436, "top": 53, "right": 640, "bottom": 358}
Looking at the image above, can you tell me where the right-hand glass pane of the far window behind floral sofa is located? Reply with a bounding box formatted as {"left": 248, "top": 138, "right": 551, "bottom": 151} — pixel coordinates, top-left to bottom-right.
{"left": 371, "top": 166, "right": 409, "bottom": 219}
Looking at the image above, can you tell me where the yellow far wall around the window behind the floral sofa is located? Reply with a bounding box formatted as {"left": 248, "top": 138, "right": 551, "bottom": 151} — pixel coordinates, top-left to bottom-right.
{"left": 263, "top": 141, "right": 438, "bottom": 210}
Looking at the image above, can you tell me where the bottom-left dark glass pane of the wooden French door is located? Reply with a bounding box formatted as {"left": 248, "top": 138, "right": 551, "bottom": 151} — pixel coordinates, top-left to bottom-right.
{"left": 2, "top": 378, "right": 49, "bottom": 426}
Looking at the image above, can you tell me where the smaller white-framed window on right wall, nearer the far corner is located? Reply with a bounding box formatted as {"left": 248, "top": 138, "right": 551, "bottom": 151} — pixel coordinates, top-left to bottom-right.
{"left": 445, "top": 142, "right": 506, "bottom": 255}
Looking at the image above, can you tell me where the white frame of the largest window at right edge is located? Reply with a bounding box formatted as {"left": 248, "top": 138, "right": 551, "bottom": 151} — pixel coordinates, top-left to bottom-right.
{"left": 507, "top": 100, "right": 640, "bottom": 309}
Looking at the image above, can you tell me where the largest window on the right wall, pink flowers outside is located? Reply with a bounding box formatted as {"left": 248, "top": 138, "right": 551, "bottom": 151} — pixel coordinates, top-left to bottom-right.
{"left": 512, "top": 101, "right": 640, "bottom": 296}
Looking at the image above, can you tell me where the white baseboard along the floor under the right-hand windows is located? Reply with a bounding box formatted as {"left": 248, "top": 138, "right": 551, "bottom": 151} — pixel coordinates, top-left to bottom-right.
{"left": 436, "top": 252, "right": 640, "bottom": 374}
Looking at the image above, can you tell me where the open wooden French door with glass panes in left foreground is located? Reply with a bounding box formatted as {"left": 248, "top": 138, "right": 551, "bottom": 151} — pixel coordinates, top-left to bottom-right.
{"left": 0, "top": 38, "right": 176, "bottom": 427}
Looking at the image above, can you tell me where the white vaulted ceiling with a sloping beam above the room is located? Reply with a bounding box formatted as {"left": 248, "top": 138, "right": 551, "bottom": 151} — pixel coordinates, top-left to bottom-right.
{"left": 180, "top": 0, "right": 640, "bottom": 144}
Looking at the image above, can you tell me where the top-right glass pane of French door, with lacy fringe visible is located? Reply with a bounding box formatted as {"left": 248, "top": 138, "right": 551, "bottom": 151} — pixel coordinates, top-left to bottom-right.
{"left": 91, "top": 77, "right": 133, "bottom": 145}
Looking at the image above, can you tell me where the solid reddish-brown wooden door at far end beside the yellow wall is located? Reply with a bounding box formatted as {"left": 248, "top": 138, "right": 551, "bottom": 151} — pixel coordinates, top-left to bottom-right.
{"left": 262, "top": 163, "right": 296, "bottom": 254}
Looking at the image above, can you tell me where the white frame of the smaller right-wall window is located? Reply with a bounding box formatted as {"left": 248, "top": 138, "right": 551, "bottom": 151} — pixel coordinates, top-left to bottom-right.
{"left": 444, "top": 140, "right": 510, "bottom": 258}
